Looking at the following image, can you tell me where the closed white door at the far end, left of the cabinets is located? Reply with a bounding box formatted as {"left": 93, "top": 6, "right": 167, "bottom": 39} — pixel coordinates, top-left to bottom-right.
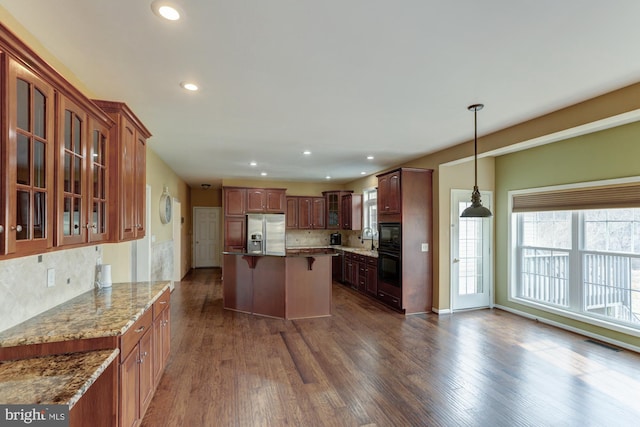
{"left": 193, "top": 208, "right": 220, "bottom": 268}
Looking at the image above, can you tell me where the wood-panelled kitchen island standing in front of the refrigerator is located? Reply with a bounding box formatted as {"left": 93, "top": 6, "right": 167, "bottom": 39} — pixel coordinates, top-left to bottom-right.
{"left": 222, "top": 248, "right": 336, "bottom": 319}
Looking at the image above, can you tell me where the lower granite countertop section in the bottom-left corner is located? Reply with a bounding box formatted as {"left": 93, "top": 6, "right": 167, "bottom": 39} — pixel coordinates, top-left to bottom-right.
{"left": 0, "top": 349, "right": 119, "bottom": 409}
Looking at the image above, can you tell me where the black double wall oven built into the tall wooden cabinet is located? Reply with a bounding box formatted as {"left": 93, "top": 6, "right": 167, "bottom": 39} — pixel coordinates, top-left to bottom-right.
{"left": 378, "top": 222, "right": 402, "bottom": 288}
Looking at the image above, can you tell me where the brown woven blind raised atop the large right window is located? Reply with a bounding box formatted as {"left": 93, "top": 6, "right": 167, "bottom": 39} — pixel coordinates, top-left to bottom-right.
{"left": 512, "top": 182, "right": 640, "bottom": 212}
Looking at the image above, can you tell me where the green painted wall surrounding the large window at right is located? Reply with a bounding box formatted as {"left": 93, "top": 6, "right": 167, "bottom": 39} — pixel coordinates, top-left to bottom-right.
{"left": 495, "top": 123, "right": 640, "bottom": 346}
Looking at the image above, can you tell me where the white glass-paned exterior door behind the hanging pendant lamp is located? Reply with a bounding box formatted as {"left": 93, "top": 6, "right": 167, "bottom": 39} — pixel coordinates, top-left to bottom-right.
{"left": 451, "top": 190, "right": 493, "bottom": 311}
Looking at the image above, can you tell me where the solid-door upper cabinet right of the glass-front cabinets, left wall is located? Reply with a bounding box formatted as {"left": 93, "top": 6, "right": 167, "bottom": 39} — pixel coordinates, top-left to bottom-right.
{"left": 94, "top": 100, "right": 151, "bottom": 241}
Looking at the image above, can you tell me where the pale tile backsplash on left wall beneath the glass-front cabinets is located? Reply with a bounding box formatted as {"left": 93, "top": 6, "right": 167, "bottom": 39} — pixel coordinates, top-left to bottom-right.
{"left": 0, "top": 246, "right": 102, "bottom": 331}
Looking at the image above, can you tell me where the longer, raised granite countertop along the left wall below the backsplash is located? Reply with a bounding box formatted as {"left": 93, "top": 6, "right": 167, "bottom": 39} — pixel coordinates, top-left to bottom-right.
{"left": 0, "top": 281, "right": 169, "bottom": 347}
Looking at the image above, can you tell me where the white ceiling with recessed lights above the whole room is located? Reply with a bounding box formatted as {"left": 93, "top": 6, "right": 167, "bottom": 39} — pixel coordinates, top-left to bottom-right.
{"left": 2, "top": 0, "right": 640, "bottom": 187}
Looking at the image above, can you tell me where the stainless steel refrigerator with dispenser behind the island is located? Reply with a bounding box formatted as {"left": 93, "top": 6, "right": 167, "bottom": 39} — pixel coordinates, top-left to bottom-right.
{"left": 247, "top": 214, "right": 286, "bottom": 255}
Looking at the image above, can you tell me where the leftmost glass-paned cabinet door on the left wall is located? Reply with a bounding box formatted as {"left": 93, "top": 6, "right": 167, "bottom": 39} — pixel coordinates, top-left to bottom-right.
{"left": 3, "top": 61, "right": 54, "bottom": 253}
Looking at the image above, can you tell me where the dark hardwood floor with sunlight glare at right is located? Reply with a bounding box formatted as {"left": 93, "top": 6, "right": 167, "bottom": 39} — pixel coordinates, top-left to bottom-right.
{"left": 142, "top": 269, "right": 640, "bottom": 427}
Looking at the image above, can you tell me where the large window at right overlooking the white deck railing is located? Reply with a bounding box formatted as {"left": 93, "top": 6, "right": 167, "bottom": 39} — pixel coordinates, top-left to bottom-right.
{"left": 510, "top": 187, "right": 640, "bottom": 331}
